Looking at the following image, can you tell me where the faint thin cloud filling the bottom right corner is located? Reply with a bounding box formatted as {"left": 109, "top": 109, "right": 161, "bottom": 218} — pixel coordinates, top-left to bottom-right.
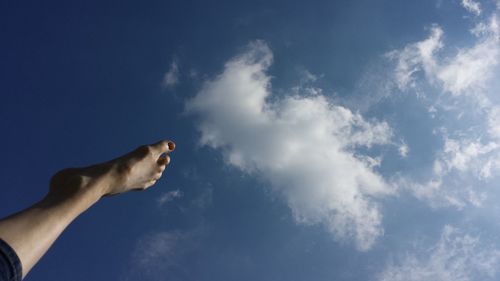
{"left": 378, "top": 226, "right": 500, "bottom": 281}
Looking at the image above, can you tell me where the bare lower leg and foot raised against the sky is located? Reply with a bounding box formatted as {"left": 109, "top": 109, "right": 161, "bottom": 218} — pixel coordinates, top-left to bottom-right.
{"left": 0, "top": 141, "right": 175, "bottom": 278}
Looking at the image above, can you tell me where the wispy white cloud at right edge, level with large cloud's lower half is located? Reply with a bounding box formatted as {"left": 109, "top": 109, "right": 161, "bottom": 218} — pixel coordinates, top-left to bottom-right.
{"left": 398, "top": 137, "right": 500, "bottom": 209}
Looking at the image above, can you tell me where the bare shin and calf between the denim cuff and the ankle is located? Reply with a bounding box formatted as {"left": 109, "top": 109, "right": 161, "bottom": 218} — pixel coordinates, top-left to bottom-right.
{"left": 0, "top": 183, "right": 100, "bottom": 278}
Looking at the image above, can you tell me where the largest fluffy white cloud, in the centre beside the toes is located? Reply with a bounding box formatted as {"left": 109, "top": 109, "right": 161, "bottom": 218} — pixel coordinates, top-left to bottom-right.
{"left": 186, "top": 41, "right": 393, "bottom": 250}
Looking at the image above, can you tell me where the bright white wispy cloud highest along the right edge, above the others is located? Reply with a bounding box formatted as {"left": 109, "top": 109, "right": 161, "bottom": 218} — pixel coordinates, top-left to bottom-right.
{"left": 388, "top": 16, "right": 500, "bottom": 96}
